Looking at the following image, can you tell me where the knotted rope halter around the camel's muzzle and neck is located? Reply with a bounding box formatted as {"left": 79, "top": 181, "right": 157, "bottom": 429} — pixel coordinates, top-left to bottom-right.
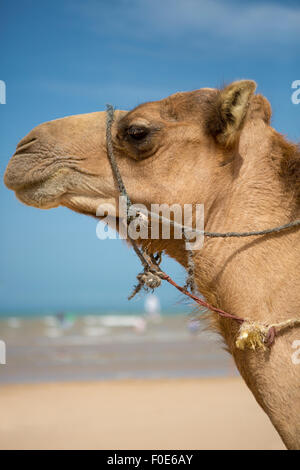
{"left": 106, "top": 105, "right": 300, "bottom": 350}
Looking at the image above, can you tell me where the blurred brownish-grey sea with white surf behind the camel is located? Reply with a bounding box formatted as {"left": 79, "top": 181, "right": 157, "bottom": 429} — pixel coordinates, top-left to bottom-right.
{"left": 0, "top": 312, "right": 237, "bottom": 384}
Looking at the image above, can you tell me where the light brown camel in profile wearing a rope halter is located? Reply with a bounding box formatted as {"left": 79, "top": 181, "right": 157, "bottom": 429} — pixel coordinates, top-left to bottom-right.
{"left": 4, "top": 80, "right": 300, "bottom": 449}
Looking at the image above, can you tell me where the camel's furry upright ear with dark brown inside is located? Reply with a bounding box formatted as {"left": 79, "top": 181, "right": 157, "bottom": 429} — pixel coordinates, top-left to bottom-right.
{"left": 207, "top": 80, "right": 256, "bottom": 147}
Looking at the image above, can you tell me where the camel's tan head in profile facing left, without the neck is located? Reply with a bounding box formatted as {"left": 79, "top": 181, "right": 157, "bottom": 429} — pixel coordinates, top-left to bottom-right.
{"left": 4, "top": 80, "right": 269, "bottom": 216}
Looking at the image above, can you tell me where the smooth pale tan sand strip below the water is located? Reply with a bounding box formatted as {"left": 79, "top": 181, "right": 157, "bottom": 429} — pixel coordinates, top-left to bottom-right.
{"left": 0, "top": 378, "right": 284, "bottom": 450}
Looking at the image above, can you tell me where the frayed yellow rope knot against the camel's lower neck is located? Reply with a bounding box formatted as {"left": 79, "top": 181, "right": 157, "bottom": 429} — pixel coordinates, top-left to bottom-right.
{"left": 235, "top": 322, "right": 268, "bottom": 351}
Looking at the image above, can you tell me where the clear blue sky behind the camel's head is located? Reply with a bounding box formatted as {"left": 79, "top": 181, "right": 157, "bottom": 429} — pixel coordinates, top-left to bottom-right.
{"left": 0, "top": 0, "right": 300, "bottom": 313}
